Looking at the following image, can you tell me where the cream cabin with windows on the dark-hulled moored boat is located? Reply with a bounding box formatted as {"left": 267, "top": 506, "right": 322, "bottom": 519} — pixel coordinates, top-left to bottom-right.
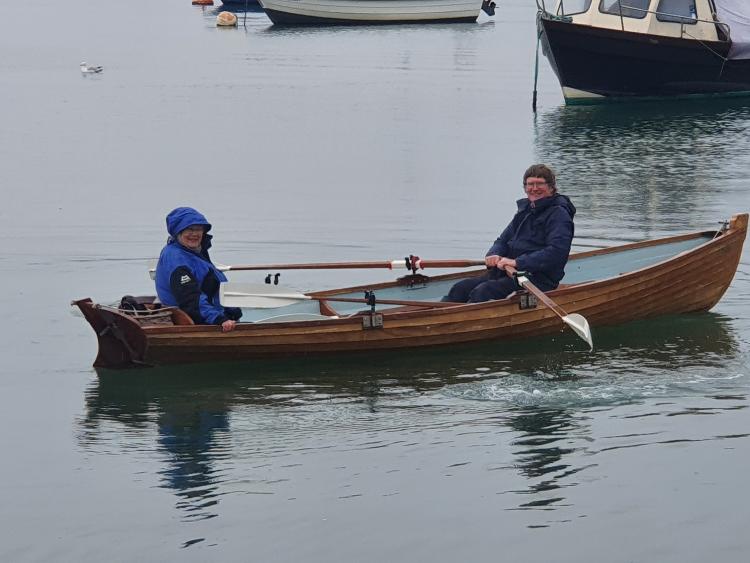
{"left": 537, "top": 0, "right": 729, "bottom": 41}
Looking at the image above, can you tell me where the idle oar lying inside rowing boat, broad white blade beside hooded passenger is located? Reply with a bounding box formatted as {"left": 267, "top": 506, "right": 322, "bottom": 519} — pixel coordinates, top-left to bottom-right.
{"left": 219, "top": 282, "right": 458, "bottom": 309}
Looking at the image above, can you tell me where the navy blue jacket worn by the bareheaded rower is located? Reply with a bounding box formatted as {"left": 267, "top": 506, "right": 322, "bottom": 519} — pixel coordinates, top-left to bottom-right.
{"left": 487, "top": 194, "right": 576, "bottom": 288}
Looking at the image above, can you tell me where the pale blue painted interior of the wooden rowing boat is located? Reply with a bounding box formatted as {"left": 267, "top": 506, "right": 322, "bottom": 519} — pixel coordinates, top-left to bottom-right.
{"left": 242, "top": 235, "right": 711, "bottom": 322}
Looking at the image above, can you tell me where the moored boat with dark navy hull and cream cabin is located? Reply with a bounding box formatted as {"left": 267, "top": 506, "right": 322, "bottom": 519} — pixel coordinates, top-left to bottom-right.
{"left": 537, "top": 0, "right": 750, "bottom": 104}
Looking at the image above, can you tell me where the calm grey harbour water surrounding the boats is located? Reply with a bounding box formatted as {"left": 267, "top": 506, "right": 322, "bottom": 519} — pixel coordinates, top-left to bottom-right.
{"left": 0, "top": 0, "right": 750, "bottom": 563}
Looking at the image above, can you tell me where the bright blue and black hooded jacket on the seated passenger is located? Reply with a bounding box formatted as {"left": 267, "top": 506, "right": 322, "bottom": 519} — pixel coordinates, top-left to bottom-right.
{"left": 156, "top": 207, "right": 242, "bottom": 325}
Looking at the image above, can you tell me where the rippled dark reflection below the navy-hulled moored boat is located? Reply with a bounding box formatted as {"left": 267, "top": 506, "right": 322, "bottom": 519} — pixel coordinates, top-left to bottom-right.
{"left": 534, "top": 103, "right": 750, "bottom": 234}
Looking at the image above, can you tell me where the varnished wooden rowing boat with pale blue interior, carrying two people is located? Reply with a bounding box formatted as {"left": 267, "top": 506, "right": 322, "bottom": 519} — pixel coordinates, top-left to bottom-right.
{"left": 73, "top": 214, "right": 748, "bottom": 368}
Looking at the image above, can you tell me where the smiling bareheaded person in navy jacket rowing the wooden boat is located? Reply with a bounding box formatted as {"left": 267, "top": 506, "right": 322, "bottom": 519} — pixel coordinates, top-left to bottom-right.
{"left": 443, "top": 164, "right": 576, "bottom": 303}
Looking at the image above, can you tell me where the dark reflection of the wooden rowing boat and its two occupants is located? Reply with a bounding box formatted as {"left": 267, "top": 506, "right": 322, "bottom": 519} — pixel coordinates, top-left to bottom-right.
{"left": 78, "top": 313, "right": 738, "bottom": 520}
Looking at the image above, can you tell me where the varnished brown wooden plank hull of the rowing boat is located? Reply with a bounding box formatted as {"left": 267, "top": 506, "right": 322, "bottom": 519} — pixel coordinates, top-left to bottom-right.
{"left": 75, "top": 214, "right": 748, "bottom": 367}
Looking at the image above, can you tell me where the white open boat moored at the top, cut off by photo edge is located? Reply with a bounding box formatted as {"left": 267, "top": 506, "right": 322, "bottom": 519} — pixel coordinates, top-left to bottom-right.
{"left": 258, "top": 0, "right": 494, "bottom": 25}
